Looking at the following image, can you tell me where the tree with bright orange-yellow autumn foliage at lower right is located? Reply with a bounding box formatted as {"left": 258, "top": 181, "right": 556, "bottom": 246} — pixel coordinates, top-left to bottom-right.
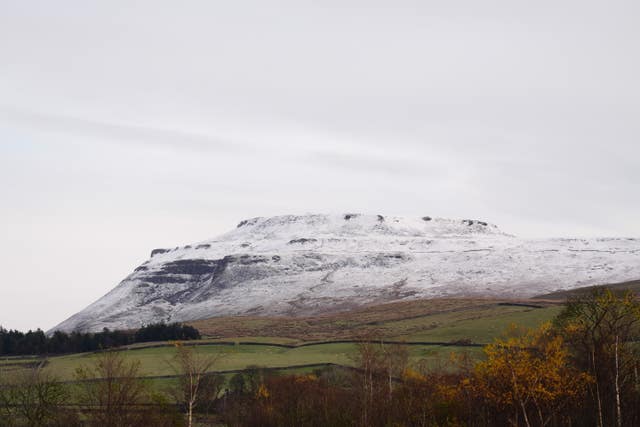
{"left": 472, "top": 324, "right": 591, "bottom": 427}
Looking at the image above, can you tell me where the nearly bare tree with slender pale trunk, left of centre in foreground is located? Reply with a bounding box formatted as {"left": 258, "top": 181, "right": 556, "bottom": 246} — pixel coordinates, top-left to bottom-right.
{"left": 170, "top": 343, "right": 222, "bottom": 427}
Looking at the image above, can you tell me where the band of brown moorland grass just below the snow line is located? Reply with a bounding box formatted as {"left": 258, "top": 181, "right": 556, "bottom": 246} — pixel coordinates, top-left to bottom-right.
{"left": 189, "top": 298, "right": 558, "bottom": 342}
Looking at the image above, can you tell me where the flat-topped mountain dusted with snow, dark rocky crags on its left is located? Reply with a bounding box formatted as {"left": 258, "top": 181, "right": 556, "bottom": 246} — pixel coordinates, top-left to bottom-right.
{"left": 53, "top": 214, "right": 640, "bottom": 331}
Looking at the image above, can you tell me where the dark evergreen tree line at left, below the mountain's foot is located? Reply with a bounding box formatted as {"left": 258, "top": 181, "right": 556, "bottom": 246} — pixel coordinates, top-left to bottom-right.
{"left": 0, "top": 323, "right": 200, "bottom": 356}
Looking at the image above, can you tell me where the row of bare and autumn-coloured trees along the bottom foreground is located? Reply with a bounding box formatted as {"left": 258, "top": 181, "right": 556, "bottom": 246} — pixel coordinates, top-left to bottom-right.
{"left": 0, "top": 290, "right": 640, "bottom": 427}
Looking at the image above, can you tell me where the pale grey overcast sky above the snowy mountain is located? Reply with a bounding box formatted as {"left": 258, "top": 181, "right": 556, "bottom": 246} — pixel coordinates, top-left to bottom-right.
{"left": 0, "top": 0, "right": 640, "bottom": 329}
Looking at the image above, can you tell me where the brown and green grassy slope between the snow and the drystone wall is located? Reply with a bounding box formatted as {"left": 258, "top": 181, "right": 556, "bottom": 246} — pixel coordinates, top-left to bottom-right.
{"left": 191, "top": 298, "right": 559, "bottom": 342}
